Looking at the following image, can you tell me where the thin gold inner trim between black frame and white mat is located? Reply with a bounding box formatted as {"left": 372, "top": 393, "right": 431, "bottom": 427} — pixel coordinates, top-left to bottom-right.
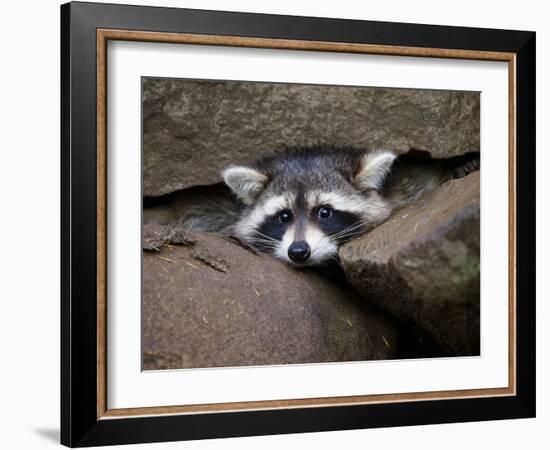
{"left": 96, "top": 29, "right": 516, "bottom": 420}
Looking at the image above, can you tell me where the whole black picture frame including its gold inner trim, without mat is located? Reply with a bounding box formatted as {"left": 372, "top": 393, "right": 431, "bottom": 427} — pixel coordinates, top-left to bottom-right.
{"left": 61, "top": 2, "right": 535, "bottom": 447}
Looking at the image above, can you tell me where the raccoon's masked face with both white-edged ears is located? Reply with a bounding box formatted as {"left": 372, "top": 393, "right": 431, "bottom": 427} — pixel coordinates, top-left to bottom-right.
{"left": 223, "top": 151, "right": 395, "bottom": 266}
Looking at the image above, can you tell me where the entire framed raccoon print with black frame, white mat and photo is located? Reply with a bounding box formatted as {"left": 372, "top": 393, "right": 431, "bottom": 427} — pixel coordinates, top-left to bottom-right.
{"left": 61, "top": 3, "right": 535, "bottom": 447}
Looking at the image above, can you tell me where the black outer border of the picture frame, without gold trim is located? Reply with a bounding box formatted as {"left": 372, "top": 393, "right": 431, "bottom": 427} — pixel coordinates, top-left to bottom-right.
{"left": 60, "top": 2, "right": 536, "bottom": 447}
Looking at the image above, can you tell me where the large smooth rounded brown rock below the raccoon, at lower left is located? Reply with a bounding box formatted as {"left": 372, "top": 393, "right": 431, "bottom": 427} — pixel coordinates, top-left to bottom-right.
{"left": 142, "top": 225, "right": 399, "bottom": 370}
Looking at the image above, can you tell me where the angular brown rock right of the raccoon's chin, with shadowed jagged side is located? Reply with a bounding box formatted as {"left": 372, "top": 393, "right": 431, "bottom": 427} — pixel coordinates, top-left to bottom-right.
{"left": 340, "top": 172, "right": 480, "bottom": 355}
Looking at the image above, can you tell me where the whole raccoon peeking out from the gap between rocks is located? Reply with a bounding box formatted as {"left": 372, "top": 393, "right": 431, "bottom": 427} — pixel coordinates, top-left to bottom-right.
{"left": 222, "top": 145, "right": 479, "bottom": 267}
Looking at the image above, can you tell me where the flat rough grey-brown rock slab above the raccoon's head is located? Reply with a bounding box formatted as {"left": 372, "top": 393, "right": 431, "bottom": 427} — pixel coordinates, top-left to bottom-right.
{"left": 143, "top": 78, "right": 480, "bottom": 196}
